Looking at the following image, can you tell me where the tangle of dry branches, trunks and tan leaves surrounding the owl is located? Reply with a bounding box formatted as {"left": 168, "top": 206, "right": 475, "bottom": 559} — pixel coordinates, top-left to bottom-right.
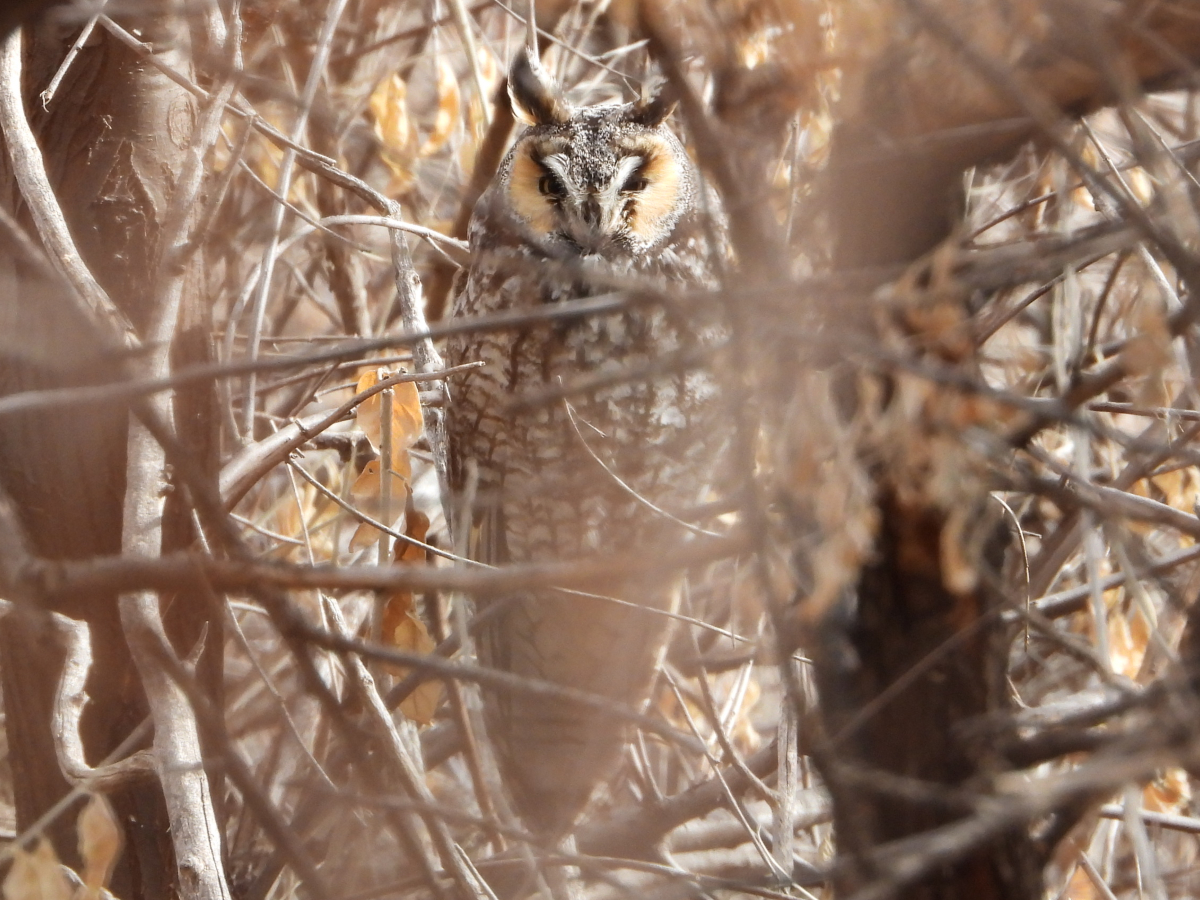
{"left": 0, "top": 0, "right": 1200, "bottom": 900}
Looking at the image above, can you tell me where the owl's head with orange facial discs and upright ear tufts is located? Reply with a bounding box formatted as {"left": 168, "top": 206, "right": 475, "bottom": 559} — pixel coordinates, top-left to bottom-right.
{"left": 500, "top": 53, "right": 697, "bottom": 258}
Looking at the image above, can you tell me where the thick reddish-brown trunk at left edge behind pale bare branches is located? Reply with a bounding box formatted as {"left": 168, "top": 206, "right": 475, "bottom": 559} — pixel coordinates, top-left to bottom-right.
{"left": 0, "top": 12, "right": 222, "bottom": 900}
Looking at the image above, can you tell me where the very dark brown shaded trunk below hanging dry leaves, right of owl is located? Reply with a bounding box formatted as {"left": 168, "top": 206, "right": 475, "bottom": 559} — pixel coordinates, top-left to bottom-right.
{"left": 816, "top": 485, "right": 1044, "bottom": 900}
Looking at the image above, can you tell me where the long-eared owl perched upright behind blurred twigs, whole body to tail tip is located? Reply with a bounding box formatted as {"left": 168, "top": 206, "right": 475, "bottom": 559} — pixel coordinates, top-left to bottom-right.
{"left": 446, "top": 53, "right": 727, "bottom": 836}
